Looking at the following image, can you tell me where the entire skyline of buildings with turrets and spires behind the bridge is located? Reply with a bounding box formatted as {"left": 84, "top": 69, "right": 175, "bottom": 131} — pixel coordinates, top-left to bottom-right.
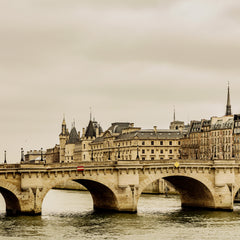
{"left": 25, "top": 83, "right": 240, "bottom": 163}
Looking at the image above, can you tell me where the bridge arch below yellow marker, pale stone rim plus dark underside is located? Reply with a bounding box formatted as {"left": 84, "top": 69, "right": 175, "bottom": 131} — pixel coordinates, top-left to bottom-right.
{"left": 139, "top": 174, "right": 215, "bottom": 208}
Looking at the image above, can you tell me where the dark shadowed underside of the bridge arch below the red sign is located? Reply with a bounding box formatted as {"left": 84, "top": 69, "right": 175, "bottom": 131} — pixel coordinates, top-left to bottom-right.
{"left": 73, "top": 179, "right": 118, "bottom": 211}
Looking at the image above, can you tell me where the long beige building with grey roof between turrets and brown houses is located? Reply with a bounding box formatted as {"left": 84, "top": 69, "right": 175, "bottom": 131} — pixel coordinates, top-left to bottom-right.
{"left": 90, "top": 122, "right": 186, "bottom": 161}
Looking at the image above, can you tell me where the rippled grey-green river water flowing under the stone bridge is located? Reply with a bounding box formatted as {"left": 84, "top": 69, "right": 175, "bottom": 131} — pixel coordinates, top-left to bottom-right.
{"left": 0, "top": 190, "right": 240, "bottom": 240}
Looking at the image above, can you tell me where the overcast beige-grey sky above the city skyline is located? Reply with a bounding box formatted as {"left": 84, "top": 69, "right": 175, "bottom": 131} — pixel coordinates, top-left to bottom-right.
{"left": 0, "top": 0, "right": 240, "bottom": 162}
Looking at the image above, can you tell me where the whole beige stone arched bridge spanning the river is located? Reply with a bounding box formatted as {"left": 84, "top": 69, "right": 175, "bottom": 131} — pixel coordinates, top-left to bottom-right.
{"left": 0, "top": 160, "right": 240, "bottom": 215}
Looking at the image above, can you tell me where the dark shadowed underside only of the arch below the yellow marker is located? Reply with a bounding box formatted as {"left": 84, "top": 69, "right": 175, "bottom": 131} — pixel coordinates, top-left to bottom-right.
{"left": 163, "top": 176, "right": 215, "bottom": 209}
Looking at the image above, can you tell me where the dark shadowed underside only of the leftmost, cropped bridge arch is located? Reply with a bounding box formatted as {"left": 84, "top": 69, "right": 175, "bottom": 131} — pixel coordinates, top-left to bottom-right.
{"left": 0, "top": 187, "right": 21, "bottom": 216}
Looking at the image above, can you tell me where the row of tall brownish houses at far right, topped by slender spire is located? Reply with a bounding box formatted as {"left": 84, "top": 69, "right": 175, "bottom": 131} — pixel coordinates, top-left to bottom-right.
{"left": 180, "top": 83, "right": 235, "bottom": 160}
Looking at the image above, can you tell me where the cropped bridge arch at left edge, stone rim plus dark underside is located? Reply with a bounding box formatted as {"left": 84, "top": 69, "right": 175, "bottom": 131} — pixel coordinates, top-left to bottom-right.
{"left": 0, "top": 181, "right": 21, "bottom": 216}
